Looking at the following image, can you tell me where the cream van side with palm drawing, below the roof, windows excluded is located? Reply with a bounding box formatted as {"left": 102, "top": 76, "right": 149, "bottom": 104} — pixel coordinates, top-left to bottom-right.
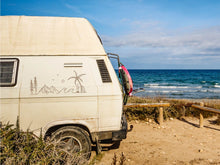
{"left": 1, "top": 56, "right": 122, "bottom": 135}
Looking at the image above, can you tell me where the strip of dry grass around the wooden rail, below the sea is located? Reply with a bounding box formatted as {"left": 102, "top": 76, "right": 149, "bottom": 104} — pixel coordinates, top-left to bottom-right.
{"left": 124, "top": 97, "right": 220, "bottom": 123}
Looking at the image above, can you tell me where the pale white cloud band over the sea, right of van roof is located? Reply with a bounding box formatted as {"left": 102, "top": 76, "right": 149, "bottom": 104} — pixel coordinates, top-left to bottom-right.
{"left": 102, "top": 22, "right": 220, "bottom": 56}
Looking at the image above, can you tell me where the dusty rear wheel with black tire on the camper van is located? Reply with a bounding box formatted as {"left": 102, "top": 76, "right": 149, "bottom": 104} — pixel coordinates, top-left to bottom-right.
{"left": 52, "top": 126, "right": 91, "bottom": 159}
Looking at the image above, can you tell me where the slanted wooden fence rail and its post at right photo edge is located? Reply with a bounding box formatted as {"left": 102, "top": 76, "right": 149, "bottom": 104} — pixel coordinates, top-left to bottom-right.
{"left": 192, "top": 102, "right": 220, "bottom": 128}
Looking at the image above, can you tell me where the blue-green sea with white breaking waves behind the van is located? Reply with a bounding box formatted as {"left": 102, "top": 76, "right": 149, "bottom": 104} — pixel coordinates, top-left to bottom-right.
{"left": 129, "top": 69, "right": 220, "bottom": 99}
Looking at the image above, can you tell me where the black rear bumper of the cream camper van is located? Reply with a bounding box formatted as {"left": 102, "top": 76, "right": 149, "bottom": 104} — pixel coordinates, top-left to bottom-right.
{"left": 91, "top": 115, "right": 128, "bottom": 142}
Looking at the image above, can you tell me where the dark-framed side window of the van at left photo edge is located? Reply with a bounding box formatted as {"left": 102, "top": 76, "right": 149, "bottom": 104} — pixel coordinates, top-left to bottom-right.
{"left": 0, "top": 58, "right": 18, "bottom": 86}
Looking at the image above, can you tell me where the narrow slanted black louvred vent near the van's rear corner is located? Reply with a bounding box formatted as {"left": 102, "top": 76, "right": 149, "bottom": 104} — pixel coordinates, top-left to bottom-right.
{"left": 96, "top": 60, "right": 112, "bottom": 83}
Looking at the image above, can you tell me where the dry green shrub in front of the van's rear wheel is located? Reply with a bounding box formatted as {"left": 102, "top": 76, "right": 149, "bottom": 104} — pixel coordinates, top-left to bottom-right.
{"left": 0, "top": 124, "right": 87, "bottom": 165}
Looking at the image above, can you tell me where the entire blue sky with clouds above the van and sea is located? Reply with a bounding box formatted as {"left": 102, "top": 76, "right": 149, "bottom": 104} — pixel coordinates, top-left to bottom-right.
{"left": 1, "top": 0, "right": 220, "bottom": 69}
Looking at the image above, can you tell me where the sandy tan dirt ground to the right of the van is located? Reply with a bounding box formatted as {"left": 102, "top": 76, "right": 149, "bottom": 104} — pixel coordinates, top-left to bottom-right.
{"left": 93, "top": 118, "right": 220, "bottom": 165}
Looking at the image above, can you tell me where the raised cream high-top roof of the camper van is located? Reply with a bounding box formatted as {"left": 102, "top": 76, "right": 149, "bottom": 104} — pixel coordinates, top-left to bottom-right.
{"left": 0, "top": 16, "right": 106, "bottom": 56}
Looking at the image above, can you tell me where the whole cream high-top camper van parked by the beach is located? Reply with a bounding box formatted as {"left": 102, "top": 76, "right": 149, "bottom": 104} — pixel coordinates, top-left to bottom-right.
{"left": 0, "top": 16, "right": 131, "bottom": 156}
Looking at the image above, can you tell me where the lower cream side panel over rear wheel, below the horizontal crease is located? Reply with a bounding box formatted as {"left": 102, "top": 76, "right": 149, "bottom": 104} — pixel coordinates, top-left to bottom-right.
{"left": 20, "top": 97, "right": 98, "bottom": 135}
